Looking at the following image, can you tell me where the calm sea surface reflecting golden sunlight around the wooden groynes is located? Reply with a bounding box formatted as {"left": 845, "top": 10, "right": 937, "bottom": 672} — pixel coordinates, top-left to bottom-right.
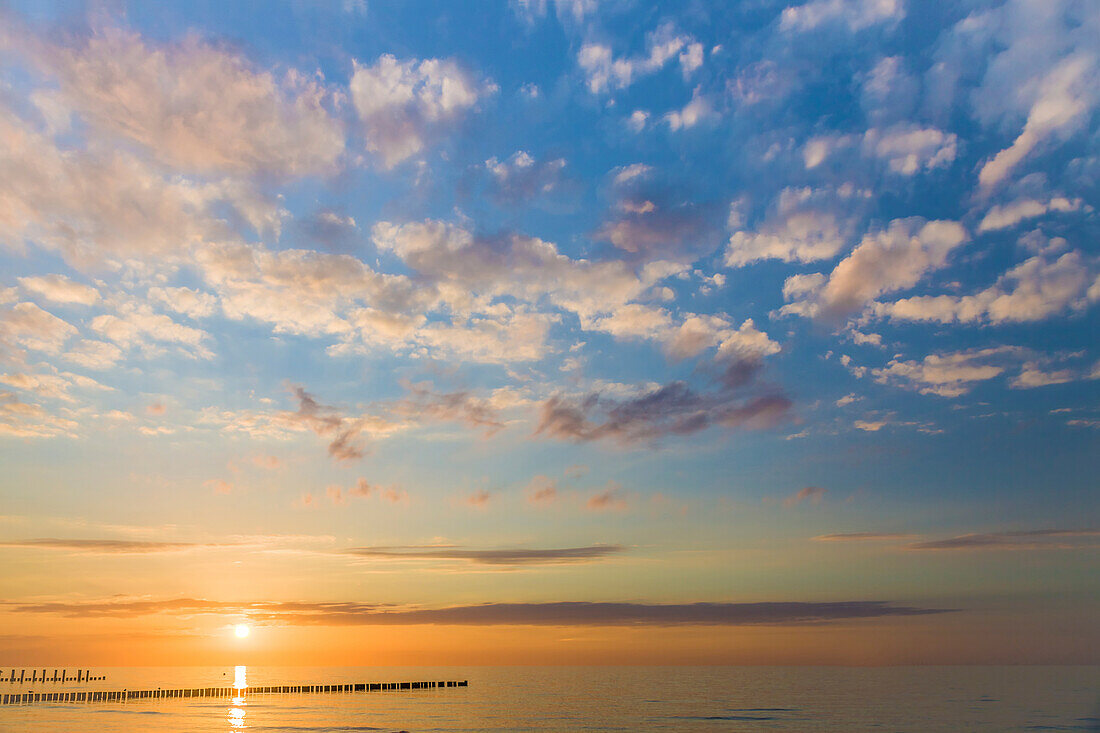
{"left": 0, "top": 667, "right": 1100, "bottom": 733}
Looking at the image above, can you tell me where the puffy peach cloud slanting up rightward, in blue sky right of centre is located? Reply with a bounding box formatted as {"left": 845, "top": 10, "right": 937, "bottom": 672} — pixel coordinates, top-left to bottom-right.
{"left": 781, "top": 218, "right": 967, "bottom": 317}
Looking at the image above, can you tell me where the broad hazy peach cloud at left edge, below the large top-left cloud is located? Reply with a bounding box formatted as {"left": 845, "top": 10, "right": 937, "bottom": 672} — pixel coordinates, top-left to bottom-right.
{"left": 0, "top": 106, "right": 275, "bottom": 266}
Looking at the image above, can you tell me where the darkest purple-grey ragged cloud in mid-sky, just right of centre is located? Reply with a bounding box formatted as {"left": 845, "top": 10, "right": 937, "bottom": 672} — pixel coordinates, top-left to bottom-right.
{"left": 535, "top": 382, "right": 791, "bottom": 446}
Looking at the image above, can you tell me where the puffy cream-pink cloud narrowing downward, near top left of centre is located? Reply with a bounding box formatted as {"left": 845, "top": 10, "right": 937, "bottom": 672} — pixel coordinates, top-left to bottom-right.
{"left": 349, "top": 54, "right": 496, "bottom": 168}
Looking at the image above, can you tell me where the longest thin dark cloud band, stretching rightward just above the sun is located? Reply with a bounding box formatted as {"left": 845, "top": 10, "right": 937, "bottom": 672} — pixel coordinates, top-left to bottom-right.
{"left": 10, "top": 599, "right": 954, "bottom": 626}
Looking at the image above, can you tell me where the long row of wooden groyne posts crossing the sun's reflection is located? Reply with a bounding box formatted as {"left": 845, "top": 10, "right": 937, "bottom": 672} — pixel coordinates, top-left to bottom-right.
{"left": 0, "top": 679, "right": 470, "bottom": 705}
